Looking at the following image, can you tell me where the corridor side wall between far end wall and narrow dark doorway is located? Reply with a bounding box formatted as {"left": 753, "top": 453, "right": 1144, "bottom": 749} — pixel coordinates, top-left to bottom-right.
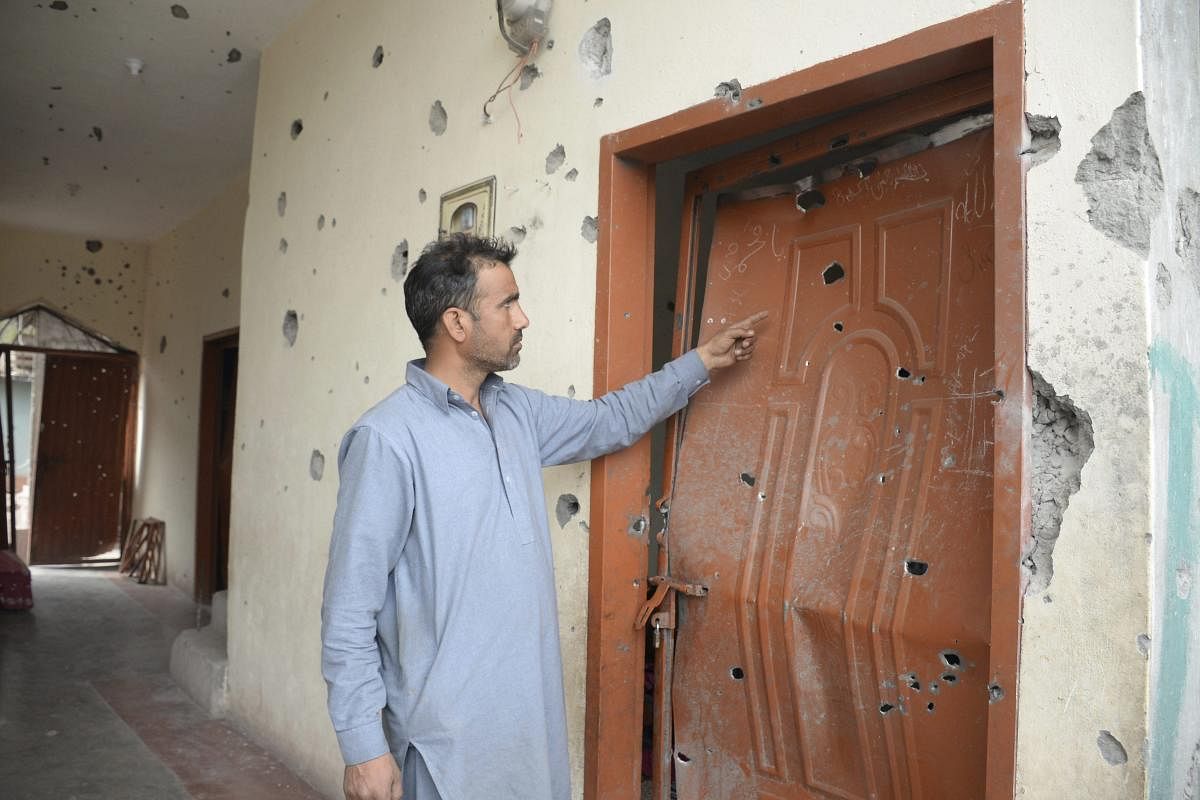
{"left": 134, "top": 174, "right": 248, "bottom": 595}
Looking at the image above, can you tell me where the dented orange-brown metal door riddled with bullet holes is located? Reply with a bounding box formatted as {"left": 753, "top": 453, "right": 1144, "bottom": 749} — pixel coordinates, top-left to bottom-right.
{"left": 671, "top": 131, "right": 998, "bottom": 800}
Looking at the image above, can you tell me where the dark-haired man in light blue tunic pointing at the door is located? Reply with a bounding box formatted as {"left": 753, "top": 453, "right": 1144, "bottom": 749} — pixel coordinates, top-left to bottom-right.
{"left": 322, "top": 235, "right": 766, "bottom": 800}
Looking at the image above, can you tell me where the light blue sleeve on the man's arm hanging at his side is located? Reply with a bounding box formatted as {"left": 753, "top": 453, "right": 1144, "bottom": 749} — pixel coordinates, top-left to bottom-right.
{"left": 320, "top": 427, "right": 414, "bottom": 764}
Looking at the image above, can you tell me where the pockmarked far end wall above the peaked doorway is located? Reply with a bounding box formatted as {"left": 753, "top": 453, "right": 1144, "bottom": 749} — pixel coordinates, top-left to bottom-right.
{"left": 0, "top": 225, "right": 146, "bottom": 350}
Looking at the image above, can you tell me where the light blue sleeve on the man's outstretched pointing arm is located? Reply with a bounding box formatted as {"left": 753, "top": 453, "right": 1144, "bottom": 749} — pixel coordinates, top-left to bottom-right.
{"left": 527, "top": 350, "right": 708, "bottom": 467}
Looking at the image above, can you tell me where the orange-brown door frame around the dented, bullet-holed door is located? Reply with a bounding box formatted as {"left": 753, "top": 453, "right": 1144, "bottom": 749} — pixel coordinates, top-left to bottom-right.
{"left": 583, "top": 0, "right": 1031, "bottom": 800}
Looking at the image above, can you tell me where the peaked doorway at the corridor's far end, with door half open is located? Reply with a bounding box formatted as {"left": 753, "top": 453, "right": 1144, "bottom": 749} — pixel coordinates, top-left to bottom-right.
{"left": 0, "top": 305, "right": 138, "bottom": 565}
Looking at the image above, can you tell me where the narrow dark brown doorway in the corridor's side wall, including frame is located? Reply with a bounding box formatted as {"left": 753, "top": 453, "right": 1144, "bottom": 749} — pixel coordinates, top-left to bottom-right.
{"left": 196, "top": 331, "right": 238, "bottom": 603}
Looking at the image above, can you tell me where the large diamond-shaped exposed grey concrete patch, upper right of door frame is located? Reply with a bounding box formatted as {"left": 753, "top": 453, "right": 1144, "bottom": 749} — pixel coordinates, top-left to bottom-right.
{"left": 1075, "top": 91, "right": 1163, "bottom": 257}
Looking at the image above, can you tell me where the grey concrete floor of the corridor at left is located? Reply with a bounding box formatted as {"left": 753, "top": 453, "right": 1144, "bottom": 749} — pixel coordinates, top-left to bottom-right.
{"left": 0, "top": 567, "right": 320, "bottom": 800}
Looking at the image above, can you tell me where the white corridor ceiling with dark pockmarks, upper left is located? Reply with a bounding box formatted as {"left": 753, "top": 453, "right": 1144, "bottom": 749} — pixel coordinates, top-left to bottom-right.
{"left": 0, "top": 0, "right": 311, "bottom": 241}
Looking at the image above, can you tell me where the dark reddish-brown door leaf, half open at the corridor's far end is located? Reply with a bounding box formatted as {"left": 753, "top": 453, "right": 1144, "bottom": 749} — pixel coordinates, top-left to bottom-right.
{"left": 30, "top": 355, "right": 133, "bottom": 564}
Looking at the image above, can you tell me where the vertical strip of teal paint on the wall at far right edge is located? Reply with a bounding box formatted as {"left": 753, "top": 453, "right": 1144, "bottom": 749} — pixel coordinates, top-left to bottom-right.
{"left": 1148, "top": 341, "right": 1200, "bottom": 798}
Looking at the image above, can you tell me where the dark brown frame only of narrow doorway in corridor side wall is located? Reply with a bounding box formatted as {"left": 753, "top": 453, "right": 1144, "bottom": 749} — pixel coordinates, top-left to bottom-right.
{"left": 192, "top": 327, "right": 239, "bottom": 604}
